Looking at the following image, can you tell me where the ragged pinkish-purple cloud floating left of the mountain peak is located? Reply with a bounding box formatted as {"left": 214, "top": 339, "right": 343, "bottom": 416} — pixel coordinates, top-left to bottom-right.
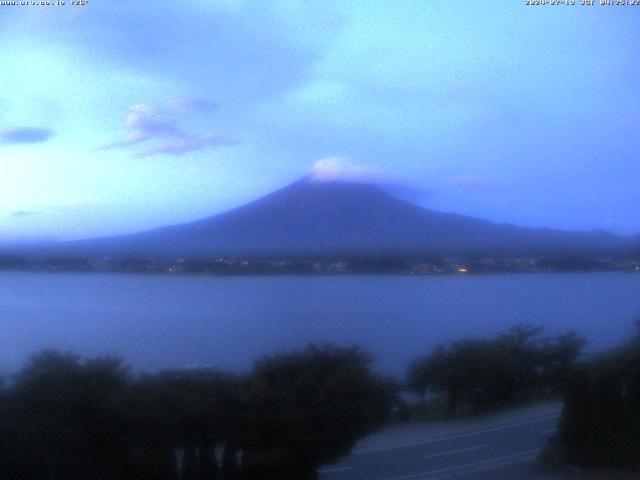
{"left": 100, "top": 98, "right": 239, "bottom": 157}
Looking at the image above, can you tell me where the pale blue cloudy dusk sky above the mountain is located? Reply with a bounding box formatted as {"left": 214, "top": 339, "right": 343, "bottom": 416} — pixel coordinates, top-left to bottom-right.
{"left": 0, "top": 0, "right": 640, "bottom": 240}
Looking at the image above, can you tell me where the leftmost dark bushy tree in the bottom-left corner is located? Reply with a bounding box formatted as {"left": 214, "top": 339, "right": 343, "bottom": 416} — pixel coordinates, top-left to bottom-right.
{"left": 10, "top": 351, "right": 131, "bottom": 480}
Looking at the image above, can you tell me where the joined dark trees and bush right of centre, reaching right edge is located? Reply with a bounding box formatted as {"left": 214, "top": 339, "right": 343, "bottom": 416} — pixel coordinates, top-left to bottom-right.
{"left": 407, "top": 320, "right": 640, "bottom": 472}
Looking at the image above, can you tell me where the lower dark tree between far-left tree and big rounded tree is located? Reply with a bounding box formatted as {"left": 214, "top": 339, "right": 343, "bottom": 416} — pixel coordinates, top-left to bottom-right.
{"left": 131, "top": 369, "right": 240, "bottom": 480}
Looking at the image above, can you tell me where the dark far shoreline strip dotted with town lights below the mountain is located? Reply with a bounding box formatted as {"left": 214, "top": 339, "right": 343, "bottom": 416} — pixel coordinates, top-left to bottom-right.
{"left": 0, "top": 254, "right": 640, "bottom": 277}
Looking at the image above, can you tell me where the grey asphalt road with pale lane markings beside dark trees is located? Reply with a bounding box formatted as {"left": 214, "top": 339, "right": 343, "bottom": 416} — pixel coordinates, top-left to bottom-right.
{"left": 319, "top": 404, "right": 560, "bottom": 480}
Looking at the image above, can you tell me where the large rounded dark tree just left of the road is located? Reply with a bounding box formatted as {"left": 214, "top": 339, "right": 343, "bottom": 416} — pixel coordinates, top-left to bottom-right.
{"left": 242, "top": 346, "right": 393, "bottom": 480}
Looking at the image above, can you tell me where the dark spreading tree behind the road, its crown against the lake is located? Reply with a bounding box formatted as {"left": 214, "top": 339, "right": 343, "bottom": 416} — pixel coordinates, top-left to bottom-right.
{"left": 407, "top": 324, "right": 584, "bottom": 415}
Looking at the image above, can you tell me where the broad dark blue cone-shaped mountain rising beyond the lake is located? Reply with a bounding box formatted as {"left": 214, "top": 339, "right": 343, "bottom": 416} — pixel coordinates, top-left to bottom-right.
{"left": 61, "top": 177, "right": 632, "bottom": 257}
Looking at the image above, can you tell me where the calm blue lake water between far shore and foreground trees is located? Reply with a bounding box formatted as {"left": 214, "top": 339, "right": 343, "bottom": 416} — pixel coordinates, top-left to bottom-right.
{"left": 0, "top": 272, "right": 640, "bottom": 374}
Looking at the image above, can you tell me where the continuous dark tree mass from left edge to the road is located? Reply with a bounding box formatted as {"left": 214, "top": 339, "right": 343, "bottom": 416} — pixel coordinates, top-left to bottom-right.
{"left": 0, "top": 346, "right": 393, "bottom": 480}
